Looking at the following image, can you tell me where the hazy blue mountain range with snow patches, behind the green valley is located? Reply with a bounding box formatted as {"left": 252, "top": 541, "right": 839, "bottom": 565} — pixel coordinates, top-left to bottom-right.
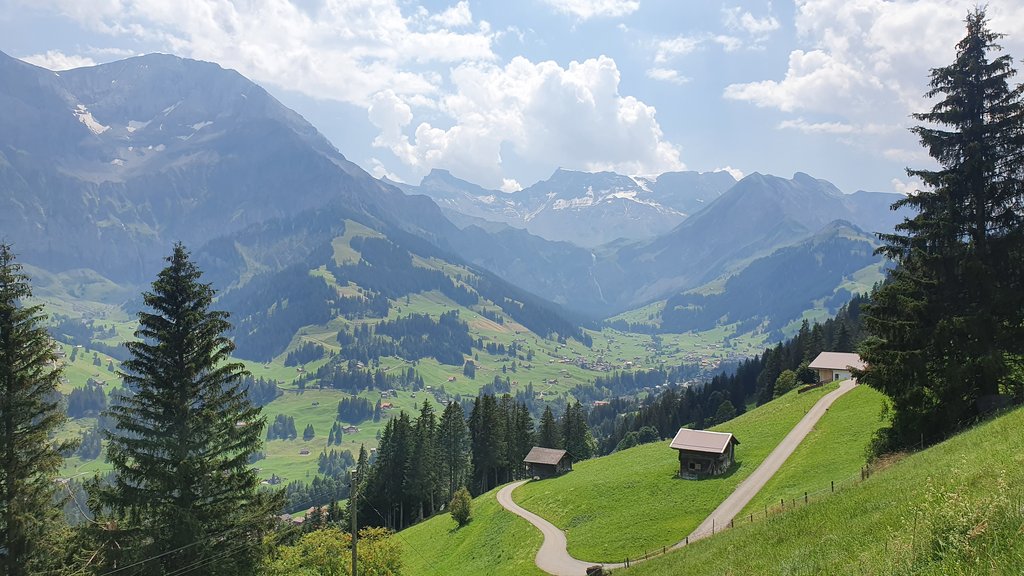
{"left": 0, "top": 52, "right": 902, "bottom": 334}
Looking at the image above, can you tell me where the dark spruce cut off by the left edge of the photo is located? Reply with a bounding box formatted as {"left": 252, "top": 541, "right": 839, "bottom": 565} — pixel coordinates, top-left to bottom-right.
{"left": 0, "top": 244, "right": 72, "bottom": 575}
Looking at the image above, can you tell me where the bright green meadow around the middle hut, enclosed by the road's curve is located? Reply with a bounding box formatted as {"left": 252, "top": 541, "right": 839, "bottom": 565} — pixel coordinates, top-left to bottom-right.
{"left": 515, "top": 384, "right": 836, "bottom": 562}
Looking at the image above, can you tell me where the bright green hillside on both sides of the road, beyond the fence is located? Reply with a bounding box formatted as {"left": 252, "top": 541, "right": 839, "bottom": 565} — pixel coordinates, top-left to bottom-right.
{"left": 391, "top": 379, "right": 882, "bottom": 575}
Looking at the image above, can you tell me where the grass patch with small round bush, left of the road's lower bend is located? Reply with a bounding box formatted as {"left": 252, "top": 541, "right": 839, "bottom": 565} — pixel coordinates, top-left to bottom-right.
{"left": 395, "top": 488, "right": 544, "bottom": 576}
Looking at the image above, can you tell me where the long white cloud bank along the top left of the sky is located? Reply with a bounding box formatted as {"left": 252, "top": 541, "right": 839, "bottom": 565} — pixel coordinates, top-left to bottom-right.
{"left": 28, "top": 0, "right": 496, "bottom": 106}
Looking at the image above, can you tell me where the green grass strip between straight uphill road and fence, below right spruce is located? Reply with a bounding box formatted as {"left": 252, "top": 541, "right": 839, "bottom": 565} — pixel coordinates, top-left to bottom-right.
{"left": 737, "top": 386, "right": 885, "bottom": 512}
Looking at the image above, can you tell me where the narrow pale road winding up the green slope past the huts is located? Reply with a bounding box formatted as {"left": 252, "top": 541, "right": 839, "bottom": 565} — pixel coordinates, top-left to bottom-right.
{"left": 498, "top": 380, "right": 857, "bottom": 576}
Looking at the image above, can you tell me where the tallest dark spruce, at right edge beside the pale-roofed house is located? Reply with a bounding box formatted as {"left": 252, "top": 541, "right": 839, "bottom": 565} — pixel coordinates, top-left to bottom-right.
{"left": 861, "top": 8, "right": 1024, "bottom": 446}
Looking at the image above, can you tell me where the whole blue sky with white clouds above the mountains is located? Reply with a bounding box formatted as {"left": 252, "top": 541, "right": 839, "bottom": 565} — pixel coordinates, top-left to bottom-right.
{"left": 0, "top": 0, "right": 1024, "bottom": 193}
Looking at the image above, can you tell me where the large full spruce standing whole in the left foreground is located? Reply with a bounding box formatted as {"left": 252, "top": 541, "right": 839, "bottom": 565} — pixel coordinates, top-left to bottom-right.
{"left": 93, "top": 244, "right": 281, "bottom": 576}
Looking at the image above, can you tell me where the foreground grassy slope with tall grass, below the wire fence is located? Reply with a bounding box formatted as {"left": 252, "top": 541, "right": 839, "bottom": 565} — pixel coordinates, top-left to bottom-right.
{"left": 616, "top": 409, "right": 1024, "bottom": 576}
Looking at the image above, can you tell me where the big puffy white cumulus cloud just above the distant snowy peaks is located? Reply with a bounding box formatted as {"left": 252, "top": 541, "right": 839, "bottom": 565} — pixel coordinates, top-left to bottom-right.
{"left": 370, "top": 56, "right": 683, "bottom": 188}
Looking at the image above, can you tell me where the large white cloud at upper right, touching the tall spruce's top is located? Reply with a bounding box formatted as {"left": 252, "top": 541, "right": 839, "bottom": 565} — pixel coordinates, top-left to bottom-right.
{"left": 723, "top": 0, "right": 1024, "bottom": 166}
